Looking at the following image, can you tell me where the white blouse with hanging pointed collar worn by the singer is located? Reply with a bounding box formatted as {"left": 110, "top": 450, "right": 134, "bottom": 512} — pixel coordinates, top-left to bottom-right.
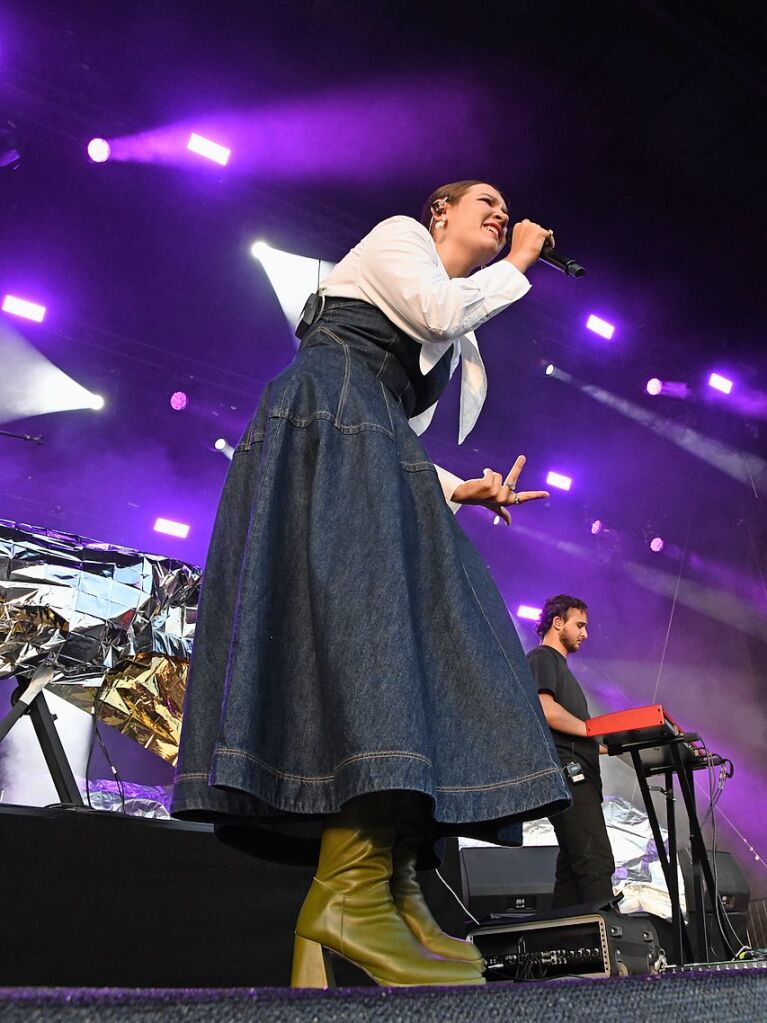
{"left": 319, "top": 217, "right": 530, "bottom": 497}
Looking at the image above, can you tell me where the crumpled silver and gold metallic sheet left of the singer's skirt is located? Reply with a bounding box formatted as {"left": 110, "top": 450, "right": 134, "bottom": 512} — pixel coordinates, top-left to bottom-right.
{"left": 0, "top": 520, "right": 200, "bottom": 763}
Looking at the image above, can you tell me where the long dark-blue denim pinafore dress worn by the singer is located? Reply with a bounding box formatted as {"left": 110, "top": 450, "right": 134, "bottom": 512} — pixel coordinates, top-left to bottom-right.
{"left": 172, "top": 299, "right": 570, "bottom": 859}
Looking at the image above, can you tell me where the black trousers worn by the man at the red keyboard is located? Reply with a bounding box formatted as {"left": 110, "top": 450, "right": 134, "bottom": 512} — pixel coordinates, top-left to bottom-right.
{"left": 549, "top": 779, "right": 616, "bottom": 909}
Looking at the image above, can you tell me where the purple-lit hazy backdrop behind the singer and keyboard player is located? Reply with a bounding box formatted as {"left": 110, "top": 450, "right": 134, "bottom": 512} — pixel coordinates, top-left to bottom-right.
{"left": 0, "top": 0, "right": 767, "bottom": 920}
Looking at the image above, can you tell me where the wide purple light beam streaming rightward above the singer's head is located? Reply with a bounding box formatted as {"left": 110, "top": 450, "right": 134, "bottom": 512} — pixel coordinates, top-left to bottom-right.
{"left": 109, "top": 79, "right": 487, "bottom": 175}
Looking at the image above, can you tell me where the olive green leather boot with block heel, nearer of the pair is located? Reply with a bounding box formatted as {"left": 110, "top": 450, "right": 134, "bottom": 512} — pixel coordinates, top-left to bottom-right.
{"left": 290, "top": 793, "right": 485, "bottom": 987}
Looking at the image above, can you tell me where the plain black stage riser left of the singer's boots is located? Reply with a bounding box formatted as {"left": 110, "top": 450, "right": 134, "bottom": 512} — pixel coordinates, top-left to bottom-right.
{"left": 0, "top": 805, "right": 314, "bottom": 987}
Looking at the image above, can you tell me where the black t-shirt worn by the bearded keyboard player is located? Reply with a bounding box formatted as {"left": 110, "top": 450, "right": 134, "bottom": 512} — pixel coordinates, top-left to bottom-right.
{"left": 528, "top": 647, "right": 601, "bottom": 791}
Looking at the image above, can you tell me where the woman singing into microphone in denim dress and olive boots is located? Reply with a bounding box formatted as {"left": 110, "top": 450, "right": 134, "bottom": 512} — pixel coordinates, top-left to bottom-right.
{"left": 173, "top": 181, "right": 569, "bottom": 986}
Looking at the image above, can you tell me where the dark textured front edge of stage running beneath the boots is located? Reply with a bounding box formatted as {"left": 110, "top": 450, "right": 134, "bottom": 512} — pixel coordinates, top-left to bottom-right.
{"left": 0, "top": 970, "right": 767, "bottom": 1023}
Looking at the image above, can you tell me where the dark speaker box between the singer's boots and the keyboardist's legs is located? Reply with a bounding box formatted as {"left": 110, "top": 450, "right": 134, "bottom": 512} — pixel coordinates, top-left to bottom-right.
{"left": 460, "top": 845, "right": 559, "bottom": 920}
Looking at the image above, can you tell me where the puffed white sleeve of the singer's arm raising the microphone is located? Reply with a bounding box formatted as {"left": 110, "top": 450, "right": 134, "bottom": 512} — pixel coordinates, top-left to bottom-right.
{"left": 356, "top": 217, "right": 530, "bottom": 343}
